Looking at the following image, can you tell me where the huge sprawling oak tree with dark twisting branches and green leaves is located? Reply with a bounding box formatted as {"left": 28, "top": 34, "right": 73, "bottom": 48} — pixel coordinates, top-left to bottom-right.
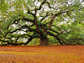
{"left": 0, "top": 0, "right": 84, "bottom": 45}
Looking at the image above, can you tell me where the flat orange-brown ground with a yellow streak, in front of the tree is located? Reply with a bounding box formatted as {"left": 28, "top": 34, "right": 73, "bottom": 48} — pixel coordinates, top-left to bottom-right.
{"left": 0, "top": 45, "right": 84, "bottom": 63}
